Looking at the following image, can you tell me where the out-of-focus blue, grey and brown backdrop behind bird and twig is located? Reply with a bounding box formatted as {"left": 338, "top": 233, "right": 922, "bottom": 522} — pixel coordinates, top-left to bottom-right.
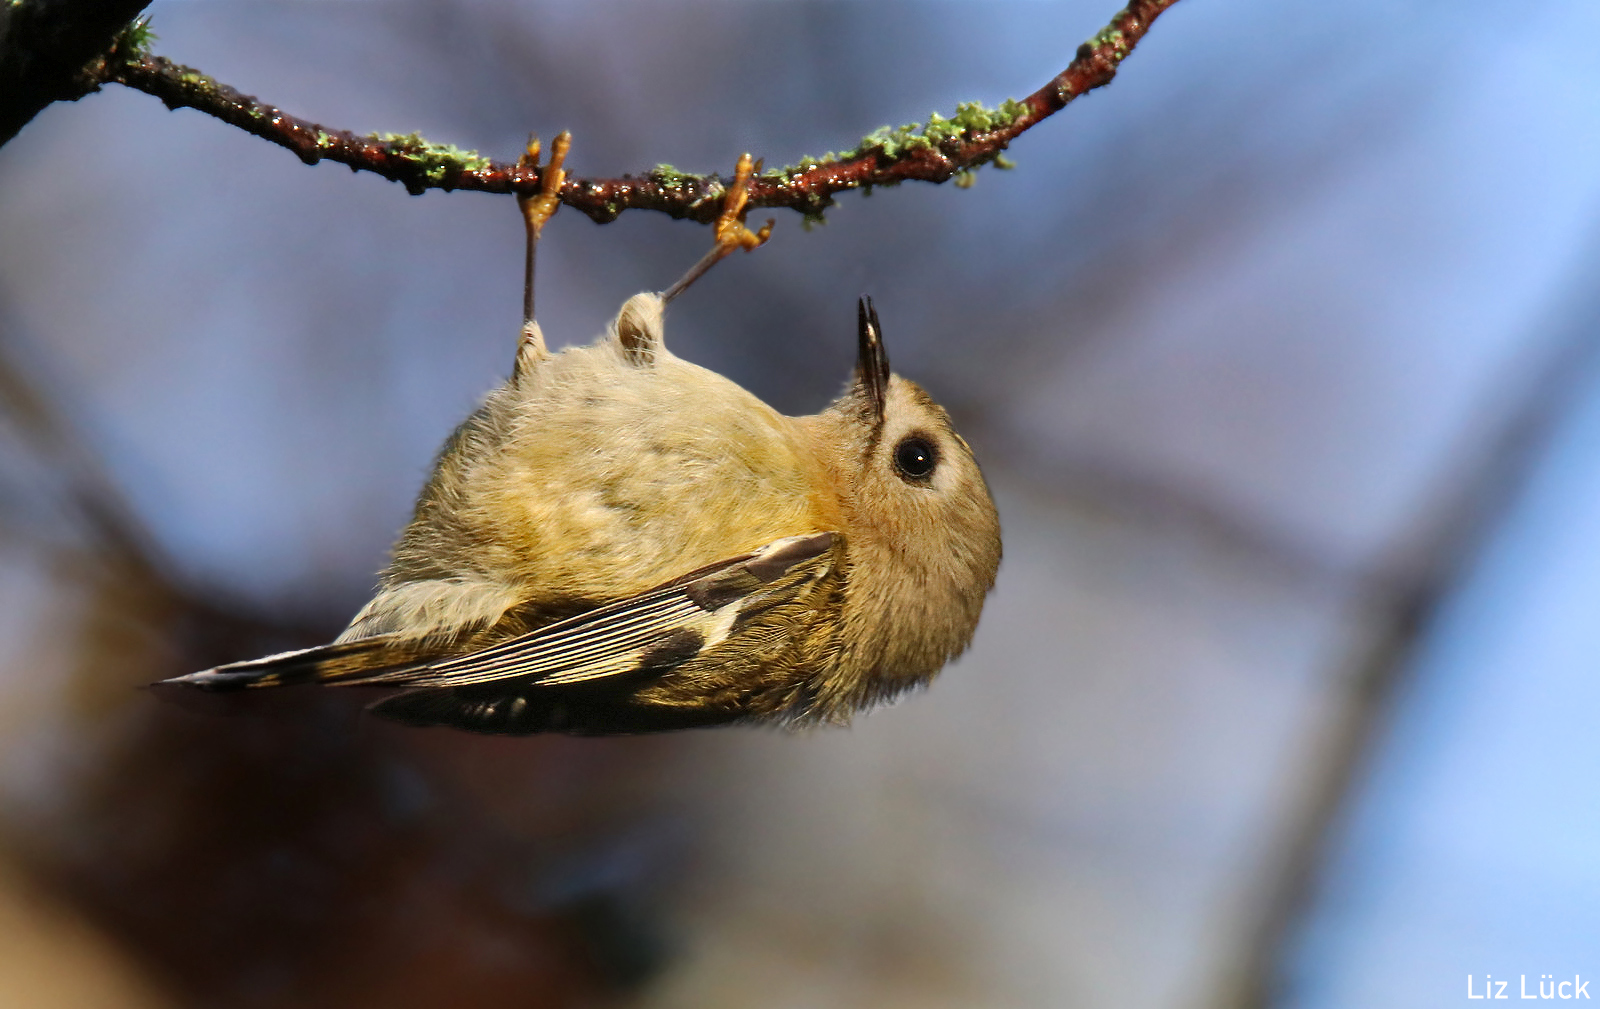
{"left": 0, "top": 0, "right": 1600, "bottom": 1009}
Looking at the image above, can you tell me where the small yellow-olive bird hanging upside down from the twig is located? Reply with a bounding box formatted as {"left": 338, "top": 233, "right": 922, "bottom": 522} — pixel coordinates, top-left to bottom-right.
{"left": 156, "top": 146, "right": 1000, "bottom": 736}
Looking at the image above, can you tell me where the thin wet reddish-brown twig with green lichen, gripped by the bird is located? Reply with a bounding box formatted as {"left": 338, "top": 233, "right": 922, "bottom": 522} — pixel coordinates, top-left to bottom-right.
{"left": 102, "top": 0, "right": 1178, "bottom": 222}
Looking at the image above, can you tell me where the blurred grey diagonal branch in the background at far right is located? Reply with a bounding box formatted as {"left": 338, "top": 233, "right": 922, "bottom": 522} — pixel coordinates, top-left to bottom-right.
{"left": 1211, "top": 238, "right": 1600, "bottom": 1009}
